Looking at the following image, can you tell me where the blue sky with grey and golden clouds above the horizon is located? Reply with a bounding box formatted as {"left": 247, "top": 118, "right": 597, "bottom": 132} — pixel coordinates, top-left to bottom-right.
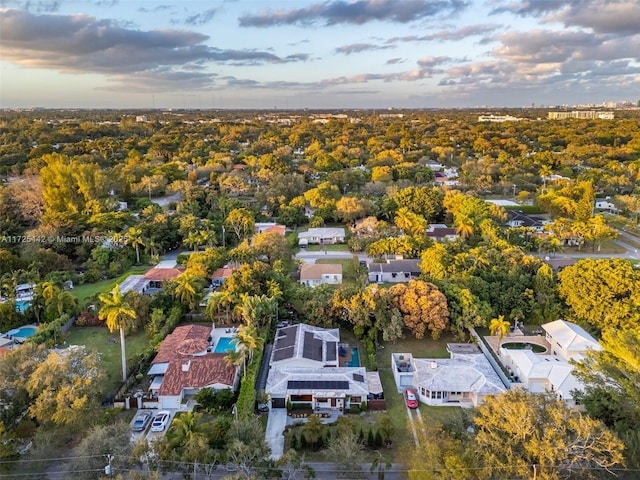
{"left": 0, "top": 0, "right": 640, "bottom": 110}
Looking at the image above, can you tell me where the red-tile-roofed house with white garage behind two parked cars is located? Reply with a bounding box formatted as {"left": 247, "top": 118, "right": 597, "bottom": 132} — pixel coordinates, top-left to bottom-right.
{"left": 147, "top": 325, "right": 240, "bottom": 409}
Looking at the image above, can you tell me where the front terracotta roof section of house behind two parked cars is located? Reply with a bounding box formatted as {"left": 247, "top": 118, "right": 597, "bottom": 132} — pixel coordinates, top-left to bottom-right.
{"left": 158, "top": 353, "right": 237, "bottom": 395}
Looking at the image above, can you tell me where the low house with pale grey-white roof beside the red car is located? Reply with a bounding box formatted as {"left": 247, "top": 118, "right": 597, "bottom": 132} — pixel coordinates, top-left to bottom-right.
{"left": 391, "top": 343, "right": 507, "bottom": 407}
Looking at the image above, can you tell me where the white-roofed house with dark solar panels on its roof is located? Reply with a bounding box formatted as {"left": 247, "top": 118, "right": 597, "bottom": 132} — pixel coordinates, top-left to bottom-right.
{"left": 265, "top": 323, "right": 384, "bottom": 412}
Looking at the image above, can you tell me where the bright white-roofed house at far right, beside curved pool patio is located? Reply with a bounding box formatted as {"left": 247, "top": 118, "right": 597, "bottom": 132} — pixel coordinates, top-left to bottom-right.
{"left": 499, "top": 320, "right": 602, "bottom": 407}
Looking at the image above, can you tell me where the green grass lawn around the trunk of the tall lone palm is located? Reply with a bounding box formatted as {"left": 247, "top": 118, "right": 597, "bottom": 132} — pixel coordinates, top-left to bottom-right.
{"left": 65, "top": 327, "right": 149, "bottom": 394}
